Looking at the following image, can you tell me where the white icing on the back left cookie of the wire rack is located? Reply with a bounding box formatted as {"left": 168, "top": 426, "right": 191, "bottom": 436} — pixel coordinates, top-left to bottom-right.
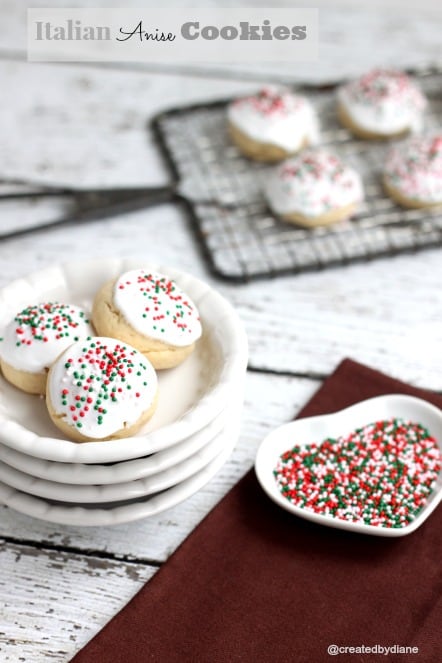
{"left": 227, "top": 85, "right": 319, "bottom": 152}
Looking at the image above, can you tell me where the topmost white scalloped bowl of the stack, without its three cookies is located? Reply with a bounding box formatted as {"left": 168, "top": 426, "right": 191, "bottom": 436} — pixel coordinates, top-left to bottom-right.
{"left": 0, "top": 258, "right": 247, "bottom": 463}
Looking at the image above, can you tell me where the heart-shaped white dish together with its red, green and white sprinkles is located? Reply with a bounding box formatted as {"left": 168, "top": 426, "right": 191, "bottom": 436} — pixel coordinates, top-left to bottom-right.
{"left": 255, "top": 395, "right": 442, "bottom": 536}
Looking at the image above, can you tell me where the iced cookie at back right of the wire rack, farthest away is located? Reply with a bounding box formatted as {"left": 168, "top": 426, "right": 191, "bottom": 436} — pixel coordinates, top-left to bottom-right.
{"left": 338, "top": 69, "right": 427, "bottom": 139}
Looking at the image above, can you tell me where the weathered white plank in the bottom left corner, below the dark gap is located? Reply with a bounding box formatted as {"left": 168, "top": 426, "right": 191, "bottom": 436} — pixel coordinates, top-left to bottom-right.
{"left": 0, "top": 539, "right": 157, "bottom": 663}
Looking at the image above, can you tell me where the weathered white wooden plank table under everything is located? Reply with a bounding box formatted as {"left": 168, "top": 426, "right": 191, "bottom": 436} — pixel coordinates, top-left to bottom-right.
{"left": 0, "top": 0, "right": 442, "bottom": 663}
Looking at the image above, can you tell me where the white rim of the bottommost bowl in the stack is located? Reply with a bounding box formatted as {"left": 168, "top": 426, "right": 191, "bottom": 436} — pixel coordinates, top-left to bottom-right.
{"left": 0, "top": 418, "right": 239, "bottom": 527}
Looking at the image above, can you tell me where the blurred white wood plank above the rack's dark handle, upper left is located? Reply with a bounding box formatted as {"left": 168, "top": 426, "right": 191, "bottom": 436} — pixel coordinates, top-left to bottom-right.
{"left": 0, "top": 61, "right": 256, "bottom": 187}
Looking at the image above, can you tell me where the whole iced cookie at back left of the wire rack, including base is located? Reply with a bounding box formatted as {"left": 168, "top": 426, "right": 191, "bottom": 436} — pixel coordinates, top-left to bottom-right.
{"left": 227, "top": 86, "right": 319, "bottom": 161}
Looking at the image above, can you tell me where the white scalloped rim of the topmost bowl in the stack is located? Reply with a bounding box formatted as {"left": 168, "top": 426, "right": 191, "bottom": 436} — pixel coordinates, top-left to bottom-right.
{"left": 0, "top": 258, "right": 247, "bottom": 463}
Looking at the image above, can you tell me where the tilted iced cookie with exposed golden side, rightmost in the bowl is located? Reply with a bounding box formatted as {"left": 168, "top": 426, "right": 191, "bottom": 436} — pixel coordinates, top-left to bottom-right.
{"left": 92, "top": 269, "right": 202, "bottom": 369}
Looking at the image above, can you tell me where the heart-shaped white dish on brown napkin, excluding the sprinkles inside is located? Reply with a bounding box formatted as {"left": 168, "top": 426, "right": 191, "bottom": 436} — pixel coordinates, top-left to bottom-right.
{"left": 255, "top": 394, "right": 442, "bottom": 537}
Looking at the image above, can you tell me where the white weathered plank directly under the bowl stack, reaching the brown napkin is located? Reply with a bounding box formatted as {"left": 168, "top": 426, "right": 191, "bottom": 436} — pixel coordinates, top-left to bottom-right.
{"left": 0, "top": 374, "right": 318, "bottom": 564}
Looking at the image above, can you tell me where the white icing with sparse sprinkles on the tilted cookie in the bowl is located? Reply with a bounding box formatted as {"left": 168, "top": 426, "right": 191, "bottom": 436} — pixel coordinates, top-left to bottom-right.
{"left": 113, "top": 269, "right": 202, "bottom": 348}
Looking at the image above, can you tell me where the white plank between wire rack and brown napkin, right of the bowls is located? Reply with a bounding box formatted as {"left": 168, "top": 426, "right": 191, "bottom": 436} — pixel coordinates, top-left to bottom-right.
{"left": 222, "top": 249, "right": 442, "bottom": 390}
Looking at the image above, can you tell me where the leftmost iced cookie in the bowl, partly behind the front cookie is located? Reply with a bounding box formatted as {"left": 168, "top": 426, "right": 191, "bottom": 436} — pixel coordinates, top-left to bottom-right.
{"left": 0, "top": 302, "right": 93, "bottom": 394}
